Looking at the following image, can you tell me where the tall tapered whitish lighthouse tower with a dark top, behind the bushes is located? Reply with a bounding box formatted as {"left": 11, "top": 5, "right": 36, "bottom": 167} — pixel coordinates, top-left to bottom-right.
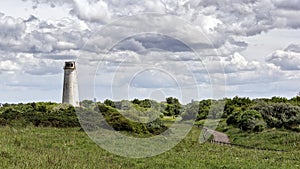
{"left": 62, "top": 62, "right": 80, "bottom": 107}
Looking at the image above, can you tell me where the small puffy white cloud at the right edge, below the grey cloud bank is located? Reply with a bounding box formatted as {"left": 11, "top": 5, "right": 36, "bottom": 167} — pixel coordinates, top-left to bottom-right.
{"left": 266, "top": 44, "right": 300, "bottom": 70}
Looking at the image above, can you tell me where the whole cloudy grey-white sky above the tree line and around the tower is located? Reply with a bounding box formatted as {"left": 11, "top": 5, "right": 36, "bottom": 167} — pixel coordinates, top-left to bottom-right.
{"left": 0, "top": 0, "right": 300, "bottom": 103}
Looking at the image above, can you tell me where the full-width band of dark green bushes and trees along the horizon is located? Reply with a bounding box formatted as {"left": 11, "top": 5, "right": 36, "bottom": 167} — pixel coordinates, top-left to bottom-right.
{"left": 0, "top": 96, "right": 300, "bottom": 134}
